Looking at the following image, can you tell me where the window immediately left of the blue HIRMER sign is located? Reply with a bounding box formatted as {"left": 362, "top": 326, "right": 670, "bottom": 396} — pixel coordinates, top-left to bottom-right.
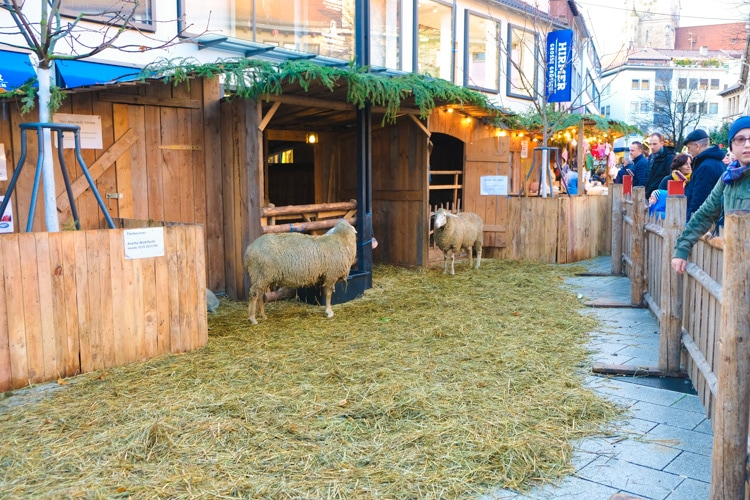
{"left": 507, "top": 25, "right": 537, "bottom": 99}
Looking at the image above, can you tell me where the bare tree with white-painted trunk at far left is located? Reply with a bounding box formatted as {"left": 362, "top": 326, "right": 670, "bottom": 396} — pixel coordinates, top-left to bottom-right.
{"left": 0, "top": 0, "right": 198, "bottom": 232}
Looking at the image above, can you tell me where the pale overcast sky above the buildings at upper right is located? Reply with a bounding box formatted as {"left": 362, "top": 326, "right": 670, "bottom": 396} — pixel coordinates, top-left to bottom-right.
{"left": 576, "top": 0, "right": 750, "bottom": 56}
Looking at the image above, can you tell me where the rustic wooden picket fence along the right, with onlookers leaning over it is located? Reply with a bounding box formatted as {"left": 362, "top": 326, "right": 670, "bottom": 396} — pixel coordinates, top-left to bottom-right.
{"left": 611, "top": 185, "right": 750, "bottom": 500}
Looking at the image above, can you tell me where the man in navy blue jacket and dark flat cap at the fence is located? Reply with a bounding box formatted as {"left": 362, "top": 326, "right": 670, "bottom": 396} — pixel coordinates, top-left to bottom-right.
{"left": 685, "top": 129, "right": 726, "bottom": 220}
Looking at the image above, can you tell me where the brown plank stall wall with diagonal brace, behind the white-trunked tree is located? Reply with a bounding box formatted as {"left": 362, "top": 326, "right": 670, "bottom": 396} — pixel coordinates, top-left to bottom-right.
{"left": 0, "top": 79, "right": 225, "bottom": 291}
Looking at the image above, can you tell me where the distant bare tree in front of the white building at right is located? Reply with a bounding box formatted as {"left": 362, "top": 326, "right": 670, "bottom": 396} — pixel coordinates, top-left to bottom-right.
{"left": 631, "top": 69, "right": 709, "bottom": 146}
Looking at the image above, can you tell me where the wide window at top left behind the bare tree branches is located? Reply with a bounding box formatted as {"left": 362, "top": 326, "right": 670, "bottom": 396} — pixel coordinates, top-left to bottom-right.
{"left": 60, "top": 0, "right": 155, "bottom": 31}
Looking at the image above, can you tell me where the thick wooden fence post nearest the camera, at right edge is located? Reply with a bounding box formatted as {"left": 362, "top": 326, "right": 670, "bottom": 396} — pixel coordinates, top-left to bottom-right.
{"left": 711, "top": 211, "right": 750, "bottom": 500}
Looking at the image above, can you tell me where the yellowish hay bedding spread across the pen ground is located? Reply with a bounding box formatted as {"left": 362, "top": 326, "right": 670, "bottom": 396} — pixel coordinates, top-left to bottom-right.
{"left": 0, "top": 259, "right": 618, "bottom": 498}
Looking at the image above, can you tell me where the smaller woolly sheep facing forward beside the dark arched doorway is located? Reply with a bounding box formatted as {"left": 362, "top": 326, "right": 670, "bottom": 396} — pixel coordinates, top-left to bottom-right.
{"left": 434, "top": 208, "right": 484, "bottom": 274}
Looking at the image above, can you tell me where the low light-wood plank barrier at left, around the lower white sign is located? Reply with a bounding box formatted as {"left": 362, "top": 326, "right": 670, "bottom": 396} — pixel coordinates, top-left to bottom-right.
{"left": 0, "top": 224, "right": 208, "bottom": 391}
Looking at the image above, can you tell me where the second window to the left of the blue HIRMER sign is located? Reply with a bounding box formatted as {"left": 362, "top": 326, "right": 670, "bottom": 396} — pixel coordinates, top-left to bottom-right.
{"left": 464, "top": 11, "right": 500, "bottom": 92}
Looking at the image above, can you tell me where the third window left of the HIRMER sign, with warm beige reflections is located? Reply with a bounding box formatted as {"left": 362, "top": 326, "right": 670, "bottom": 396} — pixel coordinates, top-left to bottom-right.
{"left": 415, "top": 0, "right": 453, "bottom": 81}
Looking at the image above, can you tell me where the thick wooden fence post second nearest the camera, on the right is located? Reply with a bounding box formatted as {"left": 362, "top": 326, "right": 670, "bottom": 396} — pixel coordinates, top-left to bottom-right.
{"left": 659, "top": 196, "right": 687, "bottom": 373}
